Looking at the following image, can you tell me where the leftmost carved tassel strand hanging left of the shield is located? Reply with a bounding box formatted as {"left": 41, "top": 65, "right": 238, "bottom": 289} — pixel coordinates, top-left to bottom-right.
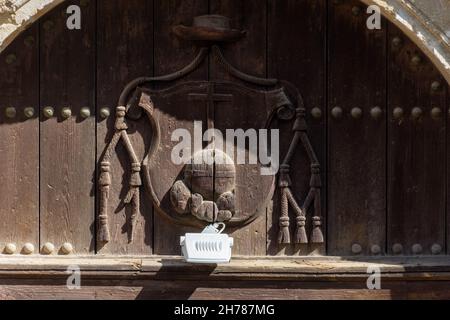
{"left": 98, "top": 162, "right": 111, "bottom": 243}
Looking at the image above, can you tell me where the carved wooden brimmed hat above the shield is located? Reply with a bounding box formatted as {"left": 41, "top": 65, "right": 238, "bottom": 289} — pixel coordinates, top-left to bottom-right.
{"left": 172, "top": 15, "right": 245, "bottom": 42}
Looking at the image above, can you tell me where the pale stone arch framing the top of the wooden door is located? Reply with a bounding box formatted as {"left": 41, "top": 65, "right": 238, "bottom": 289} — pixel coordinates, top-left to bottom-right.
{"left": 0, "top": 0, "right": 450, "bottom": 83}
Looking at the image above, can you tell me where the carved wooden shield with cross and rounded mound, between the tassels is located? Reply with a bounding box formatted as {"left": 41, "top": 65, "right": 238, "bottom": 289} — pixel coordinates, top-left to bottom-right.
{"left": 141, "top": 82, "right": 289, "bottom": 227}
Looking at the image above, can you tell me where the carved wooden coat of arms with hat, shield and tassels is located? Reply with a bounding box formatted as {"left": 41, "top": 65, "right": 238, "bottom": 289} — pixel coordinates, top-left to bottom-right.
{"left": 98, "top": 16, "right": 323, "bottom": 244}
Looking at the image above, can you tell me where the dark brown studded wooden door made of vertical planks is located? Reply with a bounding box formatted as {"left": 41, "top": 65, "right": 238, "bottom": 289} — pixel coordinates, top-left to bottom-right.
{"left": 0, "top": 0, "right": 450, "bottom": 256}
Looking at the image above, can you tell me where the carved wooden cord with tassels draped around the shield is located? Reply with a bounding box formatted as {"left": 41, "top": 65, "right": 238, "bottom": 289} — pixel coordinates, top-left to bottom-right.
{"left": 98, "top": 46, "right": 324, "bottom": 244}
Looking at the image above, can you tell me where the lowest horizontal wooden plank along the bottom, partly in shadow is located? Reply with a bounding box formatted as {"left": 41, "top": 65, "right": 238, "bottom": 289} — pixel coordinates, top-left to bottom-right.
{"left": 0, "top": 279, "right": 450, "bottom": 300}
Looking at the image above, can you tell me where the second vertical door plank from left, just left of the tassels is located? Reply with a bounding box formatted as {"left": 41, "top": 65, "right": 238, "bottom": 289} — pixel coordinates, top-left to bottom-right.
{"left": 40, "top": 1, "right": 95, "bottom": 254}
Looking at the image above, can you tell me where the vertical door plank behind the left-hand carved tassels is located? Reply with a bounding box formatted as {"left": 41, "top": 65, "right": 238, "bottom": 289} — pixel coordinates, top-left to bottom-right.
{"left": 97, "top": 0, "right": 154, "bottom": 255}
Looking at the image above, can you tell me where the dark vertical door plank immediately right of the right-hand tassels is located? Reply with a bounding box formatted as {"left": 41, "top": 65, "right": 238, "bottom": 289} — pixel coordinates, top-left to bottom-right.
{"left": 327, "top": 1, "right": 386, "bottom": 255}
